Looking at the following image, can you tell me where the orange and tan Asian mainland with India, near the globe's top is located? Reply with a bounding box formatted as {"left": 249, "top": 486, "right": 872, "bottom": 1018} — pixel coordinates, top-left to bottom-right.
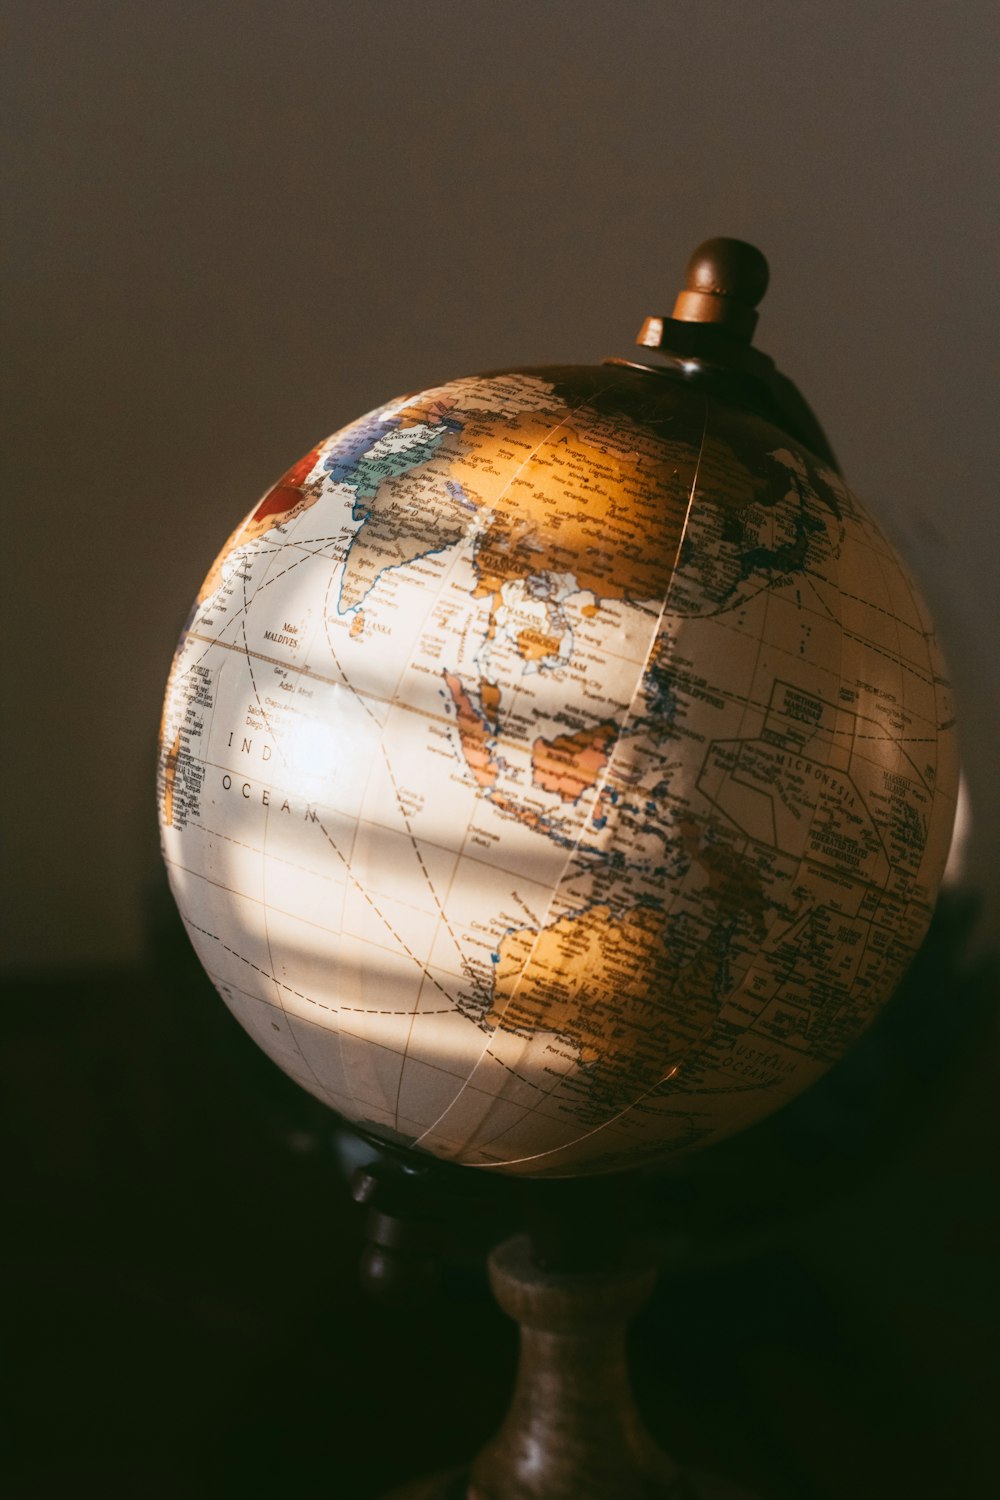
{"left": 328, "top": 393, "right": 754, "bottom": 639}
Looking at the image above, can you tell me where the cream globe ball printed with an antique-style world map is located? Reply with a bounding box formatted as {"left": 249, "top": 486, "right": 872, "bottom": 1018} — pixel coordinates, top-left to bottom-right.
{"left": 159, "top": 366, "right": 957, "bottom": 1175}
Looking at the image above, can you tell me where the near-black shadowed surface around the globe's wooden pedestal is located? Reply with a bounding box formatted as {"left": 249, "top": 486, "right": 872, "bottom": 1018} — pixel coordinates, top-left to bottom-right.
{"left": 0, "top": 902, "right": 1000, "bottom": 1500}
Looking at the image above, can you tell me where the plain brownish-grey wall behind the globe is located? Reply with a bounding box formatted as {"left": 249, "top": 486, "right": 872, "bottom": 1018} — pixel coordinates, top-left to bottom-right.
{"left": 7, "top": 0, "right": 1000, "bottom": 969}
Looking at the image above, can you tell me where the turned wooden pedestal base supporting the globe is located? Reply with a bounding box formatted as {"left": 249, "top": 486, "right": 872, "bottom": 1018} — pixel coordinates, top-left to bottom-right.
{"left": 385, "top": 1236, "right": 753, "bottom": 1500}
